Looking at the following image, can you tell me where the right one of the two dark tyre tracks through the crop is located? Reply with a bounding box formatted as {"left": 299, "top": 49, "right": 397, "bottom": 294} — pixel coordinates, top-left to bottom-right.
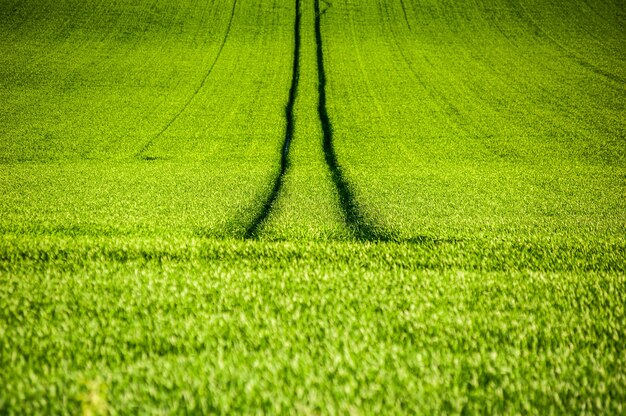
{"left": 315, "top": 0, "right": 392, "bottom": 241}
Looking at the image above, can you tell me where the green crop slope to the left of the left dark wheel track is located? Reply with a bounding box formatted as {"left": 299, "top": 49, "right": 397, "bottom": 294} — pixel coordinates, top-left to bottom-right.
{"left": 0, "top": 1, "right": 293, "bottom": 237}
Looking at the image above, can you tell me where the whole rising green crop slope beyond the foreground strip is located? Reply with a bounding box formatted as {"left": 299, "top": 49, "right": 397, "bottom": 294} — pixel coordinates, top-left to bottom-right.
{"left": 0, "top": 0, "right": 626, "bottom": 240}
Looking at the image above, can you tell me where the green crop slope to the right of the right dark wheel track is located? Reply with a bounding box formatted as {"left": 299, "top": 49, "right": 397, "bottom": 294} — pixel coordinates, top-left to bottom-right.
{"left": 323, "top": 0, "right": 626, "bottom": 240}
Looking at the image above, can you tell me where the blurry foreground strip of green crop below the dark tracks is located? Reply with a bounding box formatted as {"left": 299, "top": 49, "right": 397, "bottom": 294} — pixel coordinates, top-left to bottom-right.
{"left": 0, "top": 237, "right": 626, "bottom": 414}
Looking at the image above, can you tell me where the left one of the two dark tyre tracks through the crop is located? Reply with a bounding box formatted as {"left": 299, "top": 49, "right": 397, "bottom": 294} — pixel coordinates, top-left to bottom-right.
{"left": 244, "top": 0, "right": 301, "bottom": 239}
